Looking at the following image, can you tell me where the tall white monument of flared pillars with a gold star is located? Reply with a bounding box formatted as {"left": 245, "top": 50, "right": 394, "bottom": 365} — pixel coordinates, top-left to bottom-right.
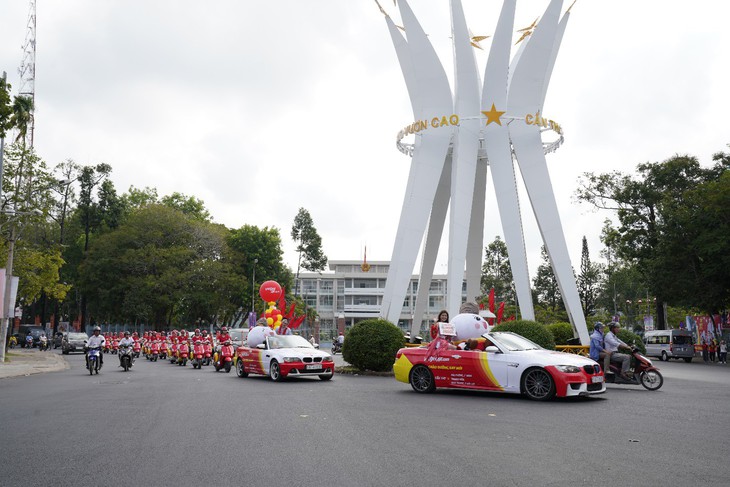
{"left": 376, "top": 0, "right": 589, "bottom": 345}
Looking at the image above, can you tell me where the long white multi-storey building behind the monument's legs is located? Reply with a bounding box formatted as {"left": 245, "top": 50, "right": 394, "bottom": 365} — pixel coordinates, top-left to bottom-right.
{"left": 299, "top": 260, "right": 466, "bottom": 340}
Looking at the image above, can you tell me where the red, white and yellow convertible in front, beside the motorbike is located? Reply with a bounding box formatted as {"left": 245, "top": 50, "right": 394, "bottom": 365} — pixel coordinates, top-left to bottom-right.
{"left": 393, "top": 332, "right": 606, "bottom": 400}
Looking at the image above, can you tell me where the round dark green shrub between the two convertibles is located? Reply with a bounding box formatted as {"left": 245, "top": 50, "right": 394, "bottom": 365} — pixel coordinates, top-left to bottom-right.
{"left": 342, "top": 319, "right": 406, "bottom": 372}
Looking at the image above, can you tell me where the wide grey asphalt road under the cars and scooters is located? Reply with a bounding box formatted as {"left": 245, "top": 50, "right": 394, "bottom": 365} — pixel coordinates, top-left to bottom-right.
{"left": 0, "top": 352, "right": 730, "bottom": 487}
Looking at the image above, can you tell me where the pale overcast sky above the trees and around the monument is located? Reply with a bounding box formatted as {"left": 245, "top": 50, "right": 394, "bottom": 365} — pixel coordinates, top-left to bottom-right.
{"left": 0, "top": 0, "right": 730, "bottom": 275}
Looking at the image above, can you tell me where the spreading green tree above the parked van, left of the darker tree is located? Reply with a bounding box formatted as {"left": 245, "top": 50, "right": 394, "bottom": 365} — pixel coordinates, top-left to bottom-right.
{"left": 576, "top": 155, "right": 728, "bottom": 329}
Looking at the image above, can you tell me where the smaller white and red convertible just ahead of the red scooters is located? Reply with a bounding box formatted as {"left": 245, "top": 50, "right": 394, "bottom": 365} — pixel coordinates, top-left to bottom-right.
{"left": 236, "top": 335, "right": 335, "bottom": 381}
